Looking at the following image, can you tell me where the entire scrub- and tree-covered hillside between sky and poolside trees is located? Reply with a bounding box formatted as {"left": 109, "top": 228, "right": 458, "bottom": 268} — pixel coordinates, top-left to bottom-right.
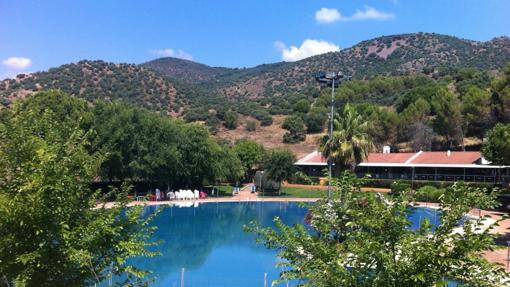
{"left": 0, "top": 33, "right": 510, "bottom": 154}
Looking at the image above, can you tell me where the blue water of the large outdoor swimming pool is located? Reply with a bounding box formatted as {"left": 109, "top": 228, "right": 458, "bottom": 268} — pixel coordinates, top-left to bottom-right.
{"left": 125, "top": 202, "right": 448, "bottom": 287}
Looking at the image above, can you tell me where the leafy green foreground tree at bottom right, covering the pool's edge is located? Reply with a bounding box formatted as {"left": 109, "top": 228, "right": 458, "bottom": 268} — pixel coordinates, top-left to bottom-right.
{"left": 247, "top": 172, "right": 510, "bottom": 287}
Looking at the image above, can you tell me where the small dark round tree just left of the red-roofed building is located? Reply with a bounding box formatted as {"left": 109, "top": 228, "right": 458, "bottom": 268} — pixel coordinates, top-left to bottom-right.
{"left": 263, "top": 150, "right": 296, "bottom": 191}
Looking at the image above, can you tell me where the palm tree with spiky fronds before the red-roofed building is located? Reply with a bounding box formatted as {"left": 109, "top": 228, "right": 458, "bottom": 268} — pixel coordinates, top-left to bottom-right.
{"left": 320, "top": 104, "right": 373, "bottom": 171}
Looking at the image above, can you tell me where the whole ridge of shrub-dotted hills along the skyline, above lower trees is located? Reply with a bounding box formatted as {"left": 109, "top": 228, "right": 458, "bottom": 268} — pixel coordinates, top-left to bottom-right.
{"left": 0, "top": 33, "right": 510, "bottom": 111}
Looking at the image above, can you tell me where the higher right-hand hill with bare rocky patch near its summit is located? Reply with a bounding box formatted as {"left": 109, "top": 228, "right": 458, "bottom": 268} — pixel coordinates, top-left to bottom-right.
{"left": 143, "top": 33, "right": 510, "bottom": 98}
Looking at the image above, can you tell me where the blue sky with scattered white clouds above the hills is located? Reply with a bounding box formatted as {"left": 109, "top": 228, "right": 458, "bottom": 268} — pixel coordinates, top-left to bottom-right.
{"left": 0, "top": 0, "right": 510, "bottom": 79}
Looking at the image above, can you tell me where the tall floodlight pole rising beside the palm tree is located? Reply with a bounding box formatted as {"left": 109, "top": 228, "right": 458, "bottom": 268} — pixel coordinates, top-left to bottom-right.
{"left": 315, "top": 72, "right": 352, "bottom": 200}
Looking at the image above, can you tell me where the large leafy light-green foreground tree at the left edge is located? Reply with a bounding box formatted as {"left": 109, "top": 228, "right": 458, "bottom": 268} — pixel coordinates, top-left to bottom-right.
{"left": 0, "top": 95, "right": 154, "bottom": 286}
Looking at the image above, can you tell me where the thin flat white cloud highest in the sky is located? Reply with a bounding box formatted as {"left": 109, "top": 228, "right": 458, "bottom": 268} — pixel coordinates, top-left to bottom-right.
{"left": 315, "top": 5, "right": 395, "bottom": 23}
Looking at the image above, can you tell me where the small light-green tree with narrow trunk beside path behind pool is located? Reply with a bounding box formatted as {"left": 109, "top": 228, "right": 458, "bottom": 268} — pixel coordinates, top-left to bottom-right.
{"left": 233, "top": 139, "right": 266, "bottom": 179}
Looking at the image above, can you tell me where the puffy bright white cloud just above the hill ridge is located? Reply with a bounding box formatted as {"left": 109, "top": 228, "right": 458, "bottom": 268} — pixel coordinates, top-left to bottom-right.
{"left": 274, "top": 39, "right": 340, "bottom": 62}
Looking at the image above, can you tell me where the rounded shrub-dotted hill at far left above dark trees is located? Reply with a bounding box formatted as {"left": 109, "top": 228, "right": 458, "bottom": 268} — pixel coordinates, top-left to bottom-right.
{"left": 0, "top": 60, "right": 187, "bottom": 111}
